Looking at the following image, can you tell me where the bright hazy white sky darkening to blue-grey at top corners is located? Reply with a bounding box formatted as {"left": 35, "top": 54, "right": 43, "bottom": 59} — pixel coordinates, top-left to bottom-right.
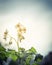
{"left": 0, "top": 0, "right": 52, "bottom": 55}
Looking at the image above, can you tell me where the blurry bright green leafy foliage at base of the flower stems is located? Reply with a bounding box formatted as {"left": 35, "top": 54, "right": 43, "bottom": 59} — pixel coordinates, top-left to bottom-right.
{"left": 0, "top": 45, "right": 42, "bottom": 65}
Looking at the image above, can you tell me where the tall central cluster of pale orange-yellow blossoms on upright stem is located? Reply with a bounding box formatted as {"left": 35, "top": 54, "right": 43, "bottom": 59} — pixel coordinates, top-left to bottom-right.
{"left": 16, "top": 23, "right": 26, "bottom": 42}
